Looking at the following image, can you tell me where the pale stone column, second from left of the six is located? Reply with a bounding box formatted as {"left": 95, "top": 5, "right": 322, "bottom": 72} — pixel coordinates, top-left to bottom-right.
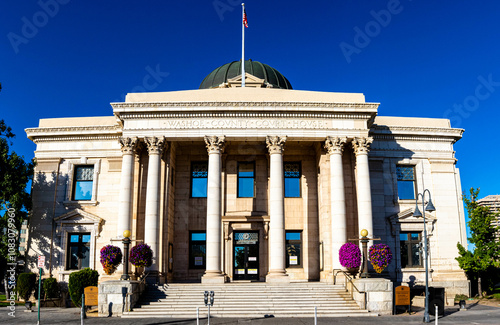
{"left": 144, "top": 137, "right": 165, "bottom": 272}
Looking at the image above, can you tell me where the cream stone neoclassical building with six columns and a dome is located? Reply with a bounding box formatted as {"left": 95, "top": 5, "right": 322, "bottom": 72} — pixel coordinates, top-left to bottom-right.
{"left": 26, "top": 60, "right": 468, "bottom": 293}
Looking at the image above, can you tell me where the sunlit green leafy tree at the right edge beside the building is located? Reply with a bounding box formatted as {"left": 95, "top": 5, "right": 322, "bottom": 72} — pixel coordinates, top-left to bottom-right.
{"left": 456, "top": 188, "right": 500, "bottom": 296}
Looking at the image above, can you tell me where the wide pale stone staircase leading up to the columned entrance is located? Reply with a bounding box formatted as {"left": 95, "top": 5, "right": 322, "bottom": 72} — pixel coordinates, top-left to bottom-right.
{"left": 122, "top": 282, "right": 377, "bottom": 318}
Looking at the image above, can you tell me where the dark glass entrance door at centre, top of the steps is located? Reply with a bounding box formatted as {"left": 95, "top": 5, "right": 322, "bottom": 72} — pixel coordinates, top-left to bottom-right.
{"left": 233, "top": 231, "right": 259, "bottom": 280}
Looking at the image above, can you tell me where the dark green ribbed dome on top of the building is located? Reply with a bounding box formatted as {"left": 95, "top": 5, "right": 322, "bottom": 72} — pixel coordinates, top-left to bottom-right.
{"left": 200, "top": 60, "right": 292, "bottom": 89}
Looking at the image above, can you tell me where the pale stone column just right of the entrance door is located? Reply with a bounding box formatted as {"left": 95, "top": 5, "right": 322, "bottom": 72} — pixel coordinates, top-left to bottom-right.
{"left": 266, "top": 136, "right": 290, "bottom": 283}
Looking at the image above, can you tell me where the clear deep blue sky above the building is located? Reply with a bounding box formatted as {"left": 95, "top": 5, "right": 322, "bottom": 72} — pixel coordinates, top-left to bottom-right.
{"left": 0, "top": 0, "right": 500, "bottom": 240}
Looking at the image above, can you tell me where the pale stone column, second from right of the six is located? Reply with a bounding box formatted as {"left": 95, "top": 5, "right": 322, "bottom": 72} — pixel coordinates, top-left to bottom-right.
{"left": 325, "top": 137, "right": 347, "bottom": 271}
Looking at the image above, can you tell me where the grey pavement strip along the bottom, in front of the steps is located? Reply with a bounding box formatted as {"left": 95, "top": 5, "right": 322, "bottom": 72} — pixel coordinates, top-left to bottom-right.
{"left": 0, "top": 305, "right": 500, "bottom": 325}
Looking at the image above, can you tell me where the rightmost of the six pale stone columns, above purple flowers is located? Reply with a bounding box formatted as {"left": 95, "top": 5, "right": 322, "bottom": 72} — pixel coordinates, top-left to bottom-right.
{"left": 352, "top": 137, "right": 373, "bottom": 243}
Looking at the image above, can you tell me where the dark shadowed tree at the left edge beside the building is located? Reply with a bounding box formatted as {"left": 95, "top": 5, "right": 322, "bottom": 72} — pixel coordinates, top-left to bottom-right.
{"left": 0, "top": 120, "right": 34, "bottom": 275}
